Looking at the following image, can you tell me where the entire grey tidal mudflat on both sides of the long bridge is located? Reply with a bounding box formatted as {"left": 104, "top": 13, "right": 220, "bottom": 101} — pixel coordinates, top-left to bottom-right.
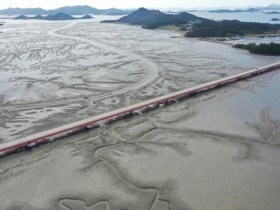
{"left": 0, "top": 16, "right": 280, "bottom": 210}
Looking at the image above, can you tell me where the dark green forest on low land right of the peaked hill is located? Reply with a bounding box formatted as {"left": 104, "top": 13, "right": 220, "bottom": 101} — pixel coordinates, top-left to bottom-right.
{"left": 186, "top": 20, "right": 280, "bottom": 37}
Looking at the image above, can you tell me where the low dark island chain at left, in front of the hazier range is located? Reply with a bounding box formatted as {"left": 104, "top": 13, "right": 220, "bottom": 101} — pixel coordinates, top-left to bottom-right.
{"left": 14, "top": 12, "right": 93, "bottom": 20}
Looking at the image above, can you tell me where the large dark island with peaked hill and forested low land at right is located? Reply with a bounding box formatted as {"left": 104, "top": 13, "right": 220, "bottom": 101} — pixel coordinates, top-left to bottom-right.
{"left": 102, "top": 8, "right": 280, "bottom": 37}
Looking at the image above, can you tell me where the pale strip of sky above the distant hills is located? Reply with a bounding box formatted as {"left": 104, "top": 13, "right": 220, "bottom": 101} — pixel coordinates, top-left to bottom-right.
{"left": 0, "top": 0, "right": 280, "bottom": 9}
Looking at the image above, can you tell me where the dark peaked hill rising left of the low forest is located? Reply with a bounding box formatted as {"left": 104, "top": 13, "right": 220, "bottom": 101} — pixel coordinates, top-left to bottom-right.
{"left": 102, "top": 8, "right": 206, "bottom": 29}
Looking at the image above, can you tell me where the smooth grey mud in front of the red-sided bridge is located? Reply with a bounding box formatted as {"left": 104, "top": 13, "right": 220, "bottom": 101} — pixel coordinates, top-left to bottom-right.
{"left": 0, "top": 70, "right": 280, "bottom": 210}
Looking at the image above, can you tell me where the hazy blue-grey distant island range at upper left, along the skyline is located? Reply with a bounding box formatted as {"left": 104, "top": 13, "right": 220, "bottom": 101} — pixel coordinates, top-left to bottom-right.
{"left": 0, "top": 5, "right": 132, "bottom": 15}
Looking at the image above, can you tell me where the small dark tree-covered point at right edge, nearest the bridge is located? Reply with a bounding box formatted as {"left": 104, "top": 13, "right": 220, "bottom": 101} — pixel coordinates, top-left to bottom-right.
{"left": 234, "top": 43, "right": 280, "bottom": 55}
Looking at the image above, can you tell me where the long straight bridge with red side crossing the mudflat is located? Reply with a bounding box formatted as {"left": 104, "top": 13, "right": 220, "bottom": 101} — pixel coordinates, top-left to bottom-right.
{"left": 0, "top": 62, "right": 280, "bottom": 156}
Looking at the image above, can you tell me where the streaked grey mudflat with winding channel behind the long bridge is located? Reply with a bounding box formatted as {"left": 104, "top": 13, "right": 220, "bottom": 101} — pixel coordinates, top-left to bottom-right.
{"left": 0, "top": 17, "right": 278, "bottom": 142}
